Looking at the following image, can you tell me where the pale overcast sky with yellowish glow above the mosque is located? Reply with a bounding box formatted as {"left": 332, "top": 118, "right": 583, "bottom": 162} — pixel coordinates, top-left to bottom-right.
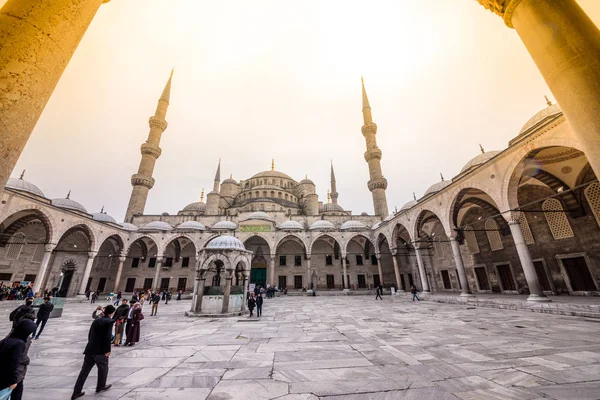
{"left": 5, "top": 0, "right": 600, "bottom": 221}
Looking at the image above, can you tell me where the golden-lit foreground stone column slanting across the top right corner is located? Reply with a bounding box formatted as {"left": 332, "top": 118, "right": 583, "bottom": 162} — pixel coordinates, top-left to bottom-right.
{"left": 479, "top": 0, "right": 600, "bottom": 176}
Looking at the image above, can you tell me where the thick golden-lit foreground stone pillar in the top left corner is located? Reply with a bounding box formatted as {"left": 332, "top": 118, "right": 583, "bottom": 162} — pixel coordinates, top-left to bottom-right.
{"left": 0, "top": 0, "right": 108, "bottom": 190}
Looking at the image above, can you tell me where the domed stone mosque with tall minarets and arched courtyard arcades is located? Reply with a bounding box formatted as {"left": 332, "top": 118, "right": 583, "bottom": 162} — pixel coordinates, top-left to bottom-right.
{"left": 0, "top": 74, "right": 600, "bottom": 301}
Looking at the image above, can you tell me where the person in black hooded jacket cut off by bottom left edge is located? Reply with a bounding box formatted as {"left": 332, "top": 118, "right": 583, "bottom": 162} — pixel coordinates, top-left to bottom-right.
{"left": 0, "top": 314, "right": 36, "bottom": 399}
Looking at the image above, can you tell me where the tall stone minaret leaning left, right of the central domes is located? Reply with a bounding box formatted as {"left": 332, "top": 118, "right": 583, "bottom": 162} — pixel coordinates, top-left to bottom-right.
{"left": 361, "top": 78, "right": 388, "bottom": 218}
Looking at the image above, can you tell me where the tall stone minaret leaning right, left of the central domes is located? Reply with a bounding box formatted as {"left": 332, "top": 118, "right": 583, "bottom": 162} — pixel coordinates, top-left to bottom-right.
{"left": 125, "top": 71, "right": 173, "bottom": 222}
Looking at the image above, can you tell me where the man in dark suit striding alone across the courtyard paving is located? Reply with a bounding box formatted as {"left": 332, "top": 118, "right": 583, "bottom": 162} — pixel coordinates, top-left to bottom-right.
{"left": 71, "top": 305, "right": 115, "bottom": 400}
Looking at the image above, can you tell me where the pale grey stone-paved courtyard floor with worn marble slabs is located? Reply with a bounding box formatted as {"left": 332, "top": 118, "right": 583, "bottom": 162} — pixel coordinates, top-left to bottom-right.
{"left": 0, "top": 296, "right": 600, "bottom": 400}
